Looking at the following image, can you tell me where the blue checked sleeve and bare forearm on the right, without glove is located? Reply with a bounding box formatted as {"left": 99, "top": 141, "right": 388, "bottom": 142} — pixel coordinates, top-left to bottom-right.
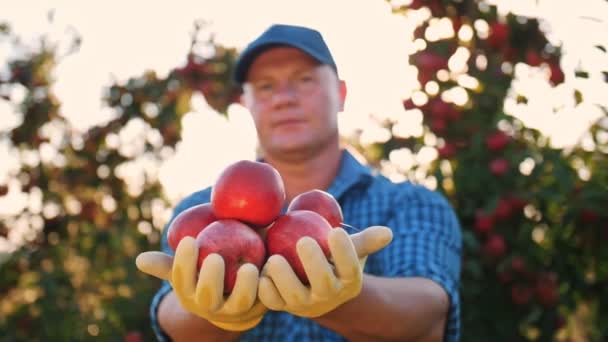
{"left": 318, "top": 187, "right": 462, "bottom": 341}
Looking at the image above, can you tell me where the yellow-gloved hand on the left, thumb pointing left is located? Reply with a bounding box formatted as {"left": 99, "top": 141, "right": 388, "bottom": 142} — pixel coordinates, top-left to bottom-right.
{"left": 135, "top": 237, "right": 267, "bottom": 331}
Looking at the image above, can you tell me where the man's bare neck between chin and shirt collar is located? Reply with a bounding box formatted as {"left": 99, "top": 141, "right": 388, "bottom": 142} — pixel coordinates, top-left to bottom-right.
{"left": 264, "top": 145, "right": 342, "bottom": 203}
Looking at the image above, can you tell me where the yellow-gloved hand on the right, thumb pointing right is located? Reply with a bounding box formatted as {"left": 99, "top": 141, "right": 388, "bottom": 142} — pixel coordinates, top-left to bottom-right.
{"left": 258, "top": 226, "right": 393, "bottom": 318}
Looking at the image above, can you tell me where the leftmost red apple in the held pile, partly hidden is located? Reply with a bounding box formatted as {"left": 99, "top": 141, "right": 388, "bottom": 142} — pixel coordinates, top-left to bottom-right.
{"left": 167, "top": 203, "right": 217, "bottom": 251}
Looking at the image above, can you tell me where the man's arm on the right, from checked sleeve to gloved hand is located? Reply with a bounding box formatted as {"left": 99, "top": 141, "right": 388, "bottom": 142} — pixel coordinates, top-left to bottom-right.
{"left": 259, "top": 187, "right": 461, "bottom": 341}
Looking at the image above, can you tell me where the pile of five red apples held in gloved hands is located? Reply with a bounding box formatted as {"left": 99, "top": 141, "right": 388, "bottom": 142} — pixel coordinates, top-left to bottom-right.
{"left": 167, "top": 160, "right": 343, "bottom": 294}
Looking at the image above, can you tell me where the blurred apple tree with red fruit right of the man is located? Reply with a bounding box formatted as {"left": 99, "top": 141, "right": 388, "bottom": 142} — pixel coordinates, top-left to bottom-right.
{"left": 354, "top": 0, "right": 608, "bottom": 341}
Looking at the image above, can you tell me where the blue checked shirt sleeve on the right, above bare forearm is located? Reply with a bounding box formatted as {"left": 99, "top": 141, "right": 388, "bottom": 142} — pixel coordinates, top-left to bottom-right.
{"left": 378, "top": 186, "right": 462, "bottom": 342}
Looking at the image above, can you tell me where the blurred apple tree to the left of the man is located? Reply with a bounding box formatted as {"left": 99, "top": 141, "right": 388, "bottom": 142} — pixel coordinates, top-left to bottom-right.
{"left": 0, "top": 21, "right": 241, "bottom": 341}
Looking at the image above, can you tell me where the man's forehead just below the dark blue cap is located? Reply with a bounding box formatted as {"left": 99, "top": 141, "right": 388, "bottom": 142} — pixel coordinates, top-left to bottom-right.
{"left": 247, "top": 46, "right": 320, "bottom": 78}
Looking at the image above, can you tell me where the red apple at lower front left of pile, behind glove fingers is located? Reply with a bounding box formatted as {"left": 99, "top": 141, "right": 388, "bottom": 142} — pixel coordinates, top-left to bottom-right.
{"left": 196, "top": 220, "right": 266, "bottom": 294}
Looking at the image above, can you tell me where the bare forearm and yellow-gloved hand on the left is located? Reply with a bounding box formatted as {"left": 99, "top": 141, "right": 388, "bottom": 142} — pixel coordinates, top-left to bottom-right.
{"left": 140, "top": 237, "right": 266, "bottom": 341}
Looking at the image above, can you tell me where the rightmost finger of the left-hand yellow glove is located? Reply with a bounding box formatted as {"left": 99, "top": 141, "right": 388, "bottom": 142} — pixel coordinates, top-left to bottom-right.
{"left": 221, "top": 263, "right": 259, "bottom": 314}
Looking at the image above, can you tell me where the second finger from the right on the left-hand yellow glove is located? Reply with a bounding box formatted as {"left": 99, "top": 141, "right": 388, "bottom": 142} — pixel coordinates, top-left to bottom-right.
{"left": 196, "top": 253, "right": 225, "bottom": 312}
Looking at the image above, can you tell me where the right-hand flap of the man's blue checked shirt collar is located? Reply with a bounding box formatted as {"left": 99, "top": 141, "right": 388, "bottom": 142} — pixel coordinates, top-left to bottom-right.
{"left": 327, "top": 150, "right": 373, "bottom": 199}
